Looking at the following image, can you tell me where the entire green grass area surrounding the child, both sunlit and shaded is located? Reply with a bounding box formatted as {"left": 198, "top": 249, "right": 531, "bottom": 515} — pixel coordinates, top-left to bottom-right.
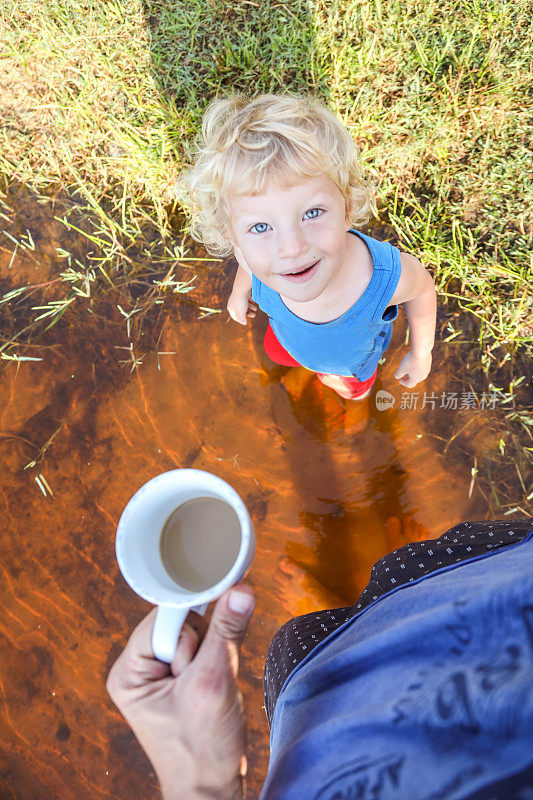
{"left": 0, "top": 0, "right": 533, "bottom": 500}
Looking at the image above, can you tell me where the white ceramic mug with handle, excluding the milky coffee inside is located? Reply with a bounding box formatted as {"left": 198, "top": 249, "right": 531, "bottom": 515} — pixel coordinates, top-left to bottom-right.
{"left": 116, "top": 469, "right": 255, "bottom": 663}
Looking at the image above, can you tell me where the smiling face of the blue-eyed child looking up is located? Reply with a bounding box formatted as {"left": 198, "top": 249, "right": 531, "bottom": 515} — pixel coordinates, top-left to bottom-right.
{"left": 228, "top": 175, "right": 350, "bottom": 303}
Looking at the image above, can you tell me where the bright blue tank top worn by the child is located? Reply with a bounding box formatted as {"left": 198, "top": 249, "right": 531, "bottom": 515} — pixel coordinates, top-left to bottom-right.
{"left": 252, "top": 230, "right": 401, "bottom": 381}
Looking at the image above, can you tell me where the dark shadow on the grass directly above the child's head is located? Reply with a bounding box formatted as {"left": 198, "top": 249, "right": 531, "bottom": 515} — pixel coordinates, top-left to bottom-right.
{"left": 143, "top": 0, "right": 326, "bottom": 120}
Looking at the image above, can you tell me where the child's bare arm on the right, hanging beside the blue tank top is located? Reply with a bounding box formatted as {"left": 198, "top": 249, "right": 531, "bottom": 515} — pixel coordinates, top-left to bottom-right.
{"left": 391, "top": 253, "right": 437, "bottom": 389}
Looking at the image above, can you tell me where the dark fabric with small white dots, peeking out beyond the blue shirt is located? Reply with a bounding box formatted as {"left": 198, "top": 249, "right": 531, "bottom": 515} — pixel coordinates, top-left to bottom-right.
{"left": 263, "top": 520, "right": 532, "bottom": 725}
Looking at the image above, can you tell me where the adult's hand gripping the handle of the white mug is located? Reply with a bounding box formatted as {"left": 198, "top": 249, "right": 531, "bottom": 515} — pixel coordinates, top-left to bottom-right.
{"left": 107, "top": 584, "right": 255, "bottom": 800}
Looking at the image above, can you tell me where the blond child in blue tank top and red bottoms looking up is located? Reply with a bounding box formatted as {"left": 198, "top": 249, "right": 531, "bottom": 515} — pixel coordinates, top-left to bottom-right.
{"left": 183, "top": 94, "right": 436, "bottom": 400}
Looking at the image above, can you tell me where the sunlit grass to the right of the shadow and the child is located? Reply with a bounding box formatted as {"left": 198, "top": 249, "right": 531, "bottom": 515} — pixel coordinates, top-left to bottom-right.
{"left": 310, "top": 0, "right": 533, "bottom": 367}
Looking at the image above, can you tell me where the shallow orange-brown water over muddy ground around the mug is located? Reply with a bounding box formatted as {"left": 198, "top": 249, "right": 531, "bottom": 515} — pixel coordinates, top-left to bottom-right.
{"left": 0, "top": 194, "right": 524, "bottom": 800}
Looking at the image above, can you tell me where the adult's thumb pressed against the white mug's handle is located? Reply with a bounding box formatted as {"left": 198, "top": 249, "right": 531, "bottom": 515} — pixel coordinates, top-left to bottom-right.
{"left": 195, "top": 584, "right": 255, "bottom": 675}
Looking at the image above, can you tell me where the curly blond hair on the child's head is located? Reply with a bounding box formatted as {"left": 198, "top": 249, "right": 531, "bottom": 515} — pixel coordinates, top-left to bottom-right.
{"left": 178, "top": 94, "right": 372, "bottom": 256}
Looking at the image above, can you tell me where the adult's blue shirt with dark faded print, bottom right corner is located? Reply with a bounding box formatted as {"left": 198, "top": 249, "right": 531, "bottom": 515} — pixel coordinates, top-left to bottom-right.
{"left": 261, "top": 521, "right": 533, "bottom": 800}
